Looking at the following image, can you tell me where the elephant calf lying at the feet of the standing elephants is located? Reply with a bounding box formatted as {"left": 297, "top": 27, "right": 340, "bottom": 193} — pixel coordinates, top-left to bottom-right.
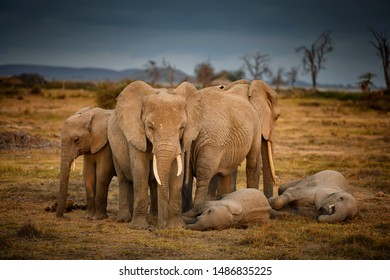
{"left": 183, "top": 188, "right": 271, "bottom": 230}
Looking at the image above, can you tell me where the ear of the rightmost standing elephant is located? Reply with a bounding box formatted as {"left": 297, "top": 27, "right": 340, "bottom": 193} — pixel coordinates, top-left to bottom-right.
{"left": 249, "top": 80, "right": 280, "bottom": 141}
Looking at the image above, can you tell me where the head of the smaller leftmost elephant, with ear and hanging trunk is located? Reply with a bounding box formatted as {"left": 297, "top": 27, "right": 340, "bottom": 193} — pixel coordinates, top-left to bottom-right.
{"left": 56, "top": 107, "right": 111, "bottom": 217}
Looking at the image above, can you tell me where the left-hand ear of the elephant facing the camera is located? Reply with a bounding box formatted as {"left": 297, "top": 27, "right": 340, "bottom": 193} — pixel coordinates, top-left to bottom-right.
{"left": 115, "top": 81, "right": 157, "bottom": 152}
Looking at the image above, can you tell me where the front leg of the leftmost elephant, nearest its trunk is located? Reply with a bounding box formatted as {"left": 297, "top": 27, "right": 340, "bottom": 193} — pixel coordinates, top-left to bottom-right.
{"left": 83, "top": 154, "right": 96, "bottom": 219}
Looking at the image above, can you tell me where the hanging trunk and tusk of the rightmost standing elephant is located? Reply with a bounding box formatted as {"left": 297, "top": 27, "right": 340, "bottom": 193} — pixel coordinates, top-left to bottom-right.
{"left": 261, "top": 138, "right": 276, "bottom": 198}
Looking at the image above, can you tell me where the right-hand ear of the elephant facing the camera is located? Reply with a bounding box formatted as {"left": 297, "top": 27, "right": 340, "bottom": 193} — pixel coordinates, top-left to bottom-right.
{"left": 173, "top": 82, "right": 203, "bottom": 151}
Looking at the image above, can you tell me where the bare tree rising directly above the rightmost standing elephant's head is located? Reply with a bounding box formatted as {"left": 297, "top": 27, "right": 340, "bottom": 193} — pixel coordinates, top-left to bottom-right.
{"left": 241, "top": 51, "right": 271, "bottom": 80}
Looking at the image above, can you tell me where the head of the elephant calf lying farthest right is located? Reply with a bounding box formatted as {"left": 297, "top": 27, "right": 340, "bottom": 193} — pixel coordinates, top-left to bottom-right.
{"left": 314, "top": 191, "right": 358, "bottom": 223}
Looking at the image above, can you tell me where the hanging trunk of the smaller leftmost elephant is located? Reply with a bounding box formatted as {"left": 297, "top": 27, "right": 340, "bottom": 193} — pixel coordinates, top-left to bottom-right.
{"left": 56, "top": 145, "right": 75, "bottom": 217}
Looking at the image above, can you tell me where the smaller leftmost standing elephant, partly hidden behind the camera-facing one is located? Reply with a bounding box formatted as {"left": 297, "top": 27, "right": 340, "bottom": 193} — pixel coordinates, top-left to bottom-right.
{"left": 56, "top": 107, "right": 115, "bottom": 220}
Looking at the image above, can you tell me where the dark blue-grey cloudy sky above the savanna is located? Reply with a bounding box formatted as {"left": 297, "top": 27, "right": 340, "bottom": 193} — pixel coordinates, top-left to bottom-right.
{"left": 0, "top": 0, "right": 390, "bottom": 86}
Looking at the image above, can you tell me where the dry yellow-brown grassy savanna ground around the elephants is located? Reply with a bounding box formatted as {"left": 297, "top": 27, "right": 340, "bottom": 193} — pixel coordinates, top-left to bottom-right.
{"left": 0, "top": 86, "right": 390, "bottom": 259}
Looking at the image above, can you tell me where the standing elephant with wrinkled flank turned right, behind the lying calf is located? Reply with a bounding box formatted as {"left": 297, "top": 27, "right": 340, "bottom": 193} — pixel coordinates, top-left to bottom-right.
{"left": 183, "top": 80, "right": 280, "bottom": 212}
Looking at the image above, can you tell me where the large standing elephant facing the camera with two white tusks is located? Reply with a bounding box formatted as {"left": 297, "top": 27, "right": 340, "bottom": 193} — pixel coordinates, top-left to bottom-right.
{"left": 108, "top": 81, "right": 202, "bottom": 229}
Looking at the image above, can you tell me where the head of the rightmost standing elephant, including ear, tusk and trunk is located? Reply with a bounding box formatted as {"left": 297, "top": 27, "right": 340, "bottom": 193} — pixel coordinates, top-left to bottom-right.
{"left": 224, "top": 80, "right": 280, "bottom": 197}
